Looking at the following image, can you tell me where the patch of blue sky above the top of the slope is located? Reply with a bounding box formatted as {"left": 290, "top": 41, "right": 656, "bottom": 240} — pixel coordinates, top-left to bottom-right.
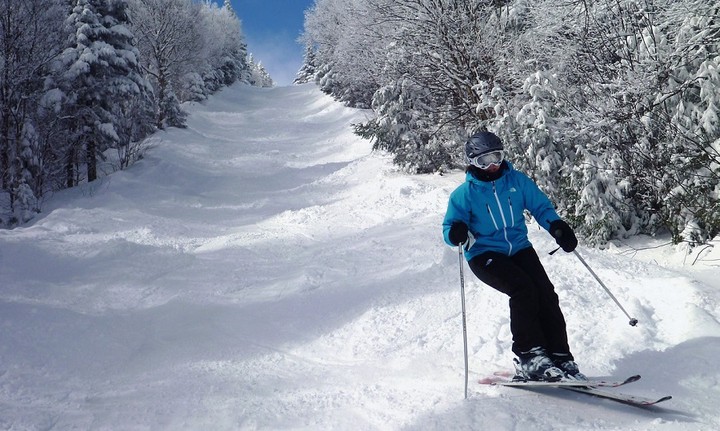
{"left": 216, "top": 0, "right": 315, "bottom": 85}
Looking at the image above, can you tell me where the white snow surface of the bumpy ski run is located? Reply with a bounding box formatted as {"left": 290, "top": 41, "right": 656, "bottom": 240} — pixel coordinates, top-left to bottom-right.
{"left": 0, "top": 85, "right": 720, "bottom": 431}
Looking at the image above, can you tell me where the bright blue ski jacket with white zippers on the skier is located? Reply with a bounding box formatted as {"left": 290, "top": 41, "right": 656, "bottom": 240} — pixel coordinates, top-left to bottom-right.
{"left": 443, "top": 161, "right": 560, "bottom": 261}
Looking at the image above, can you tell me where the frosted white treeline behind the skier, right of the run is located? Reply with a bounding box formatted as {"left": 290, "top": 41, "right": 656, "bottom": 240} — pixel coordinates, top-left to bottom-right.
{"left": 298, "top": 0, "right": 720, "bottom": 245}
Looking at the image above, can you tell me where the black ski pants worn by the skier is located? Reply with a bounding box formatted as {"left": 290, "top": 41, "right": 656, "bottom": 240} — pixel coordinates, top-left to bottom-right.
{"left": 469, "top": 247, "right": 573, "bottom": 360}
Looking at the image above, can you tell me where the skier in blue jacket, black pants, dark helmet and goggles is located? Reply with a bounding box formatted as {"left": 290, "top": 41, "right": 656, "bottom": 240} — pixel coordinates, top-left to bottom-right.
{"left": 443, "top": 132, "right": 585, "bottom": 380}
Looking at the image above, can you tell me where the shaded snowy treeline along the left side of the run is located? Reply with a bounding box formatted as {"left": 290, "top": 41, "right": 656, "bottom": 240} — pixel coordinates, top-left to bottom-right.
{"left": 0, "top": 0, "right": 272, "bottom": 226}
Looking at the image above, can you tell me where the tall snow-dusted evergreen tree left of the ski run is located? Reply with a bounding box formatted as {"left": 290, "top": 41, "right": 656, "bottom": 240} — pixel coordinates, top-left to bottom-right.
{"left": 63, "top": 0, "right": 149, "bottom": 183}
